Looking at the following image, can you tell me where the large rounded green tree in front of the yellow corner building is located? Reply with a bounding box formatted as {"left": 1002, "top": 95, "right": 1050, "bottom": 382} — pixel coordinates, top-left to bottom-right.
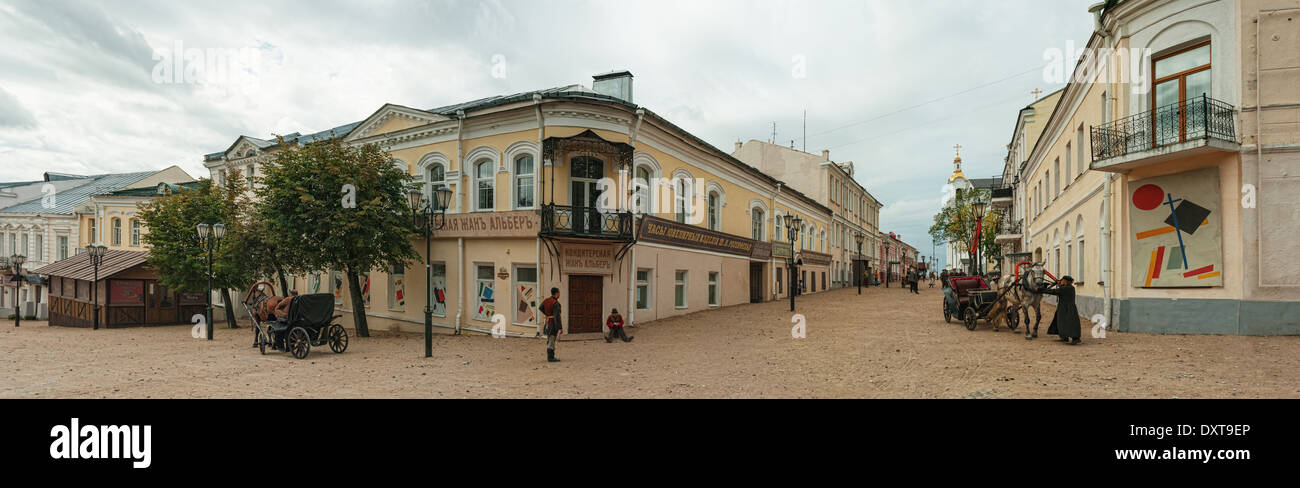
{"left": 255, "top": 139, "right": 420, "bottom": 337}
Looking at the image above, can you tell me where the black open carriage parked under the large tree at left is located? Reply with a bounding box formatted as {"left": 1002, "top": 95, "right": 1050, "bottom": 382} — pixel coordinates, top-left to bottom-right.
{"left": 243, "top": 281, "right": 347, "bottom": 359}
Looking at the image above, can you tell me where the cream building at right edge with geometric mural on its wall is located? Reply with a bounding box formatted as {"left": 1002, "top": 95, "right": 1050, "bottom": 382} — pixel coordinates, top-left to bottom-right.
{"left": 1017, "top": 0, "right": 1300, "bottom": 334}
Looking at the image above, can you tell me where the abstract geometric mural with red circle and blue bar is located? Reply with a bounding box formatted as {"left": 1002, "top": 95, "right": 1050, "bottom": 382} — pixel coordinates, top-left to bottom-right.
{"left": 1128, "top": 168, "right": 1223, "bottom": 288}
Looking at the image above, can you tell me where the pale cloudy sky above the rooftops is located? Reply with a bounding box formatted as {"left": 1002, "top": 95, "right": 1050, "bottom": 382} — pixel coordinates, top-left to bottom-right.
{"left": 0, "top": 0, "right": 1093, "bottom": 268}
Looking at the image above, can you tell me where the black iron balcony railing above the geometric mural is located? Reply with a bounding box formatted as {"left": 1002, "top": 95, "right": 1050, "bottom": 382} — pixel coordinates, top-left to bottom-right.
{"left": 1092, "top": 95, "right": 1236, "bottom": 163}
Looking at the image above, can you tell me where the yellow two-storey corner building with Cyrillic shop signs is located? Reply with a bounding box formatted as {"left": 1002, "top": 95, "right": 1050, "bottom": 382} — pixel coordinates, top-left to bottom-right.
{"left": 207, "top": 72, "right": 831, "bottom": 337}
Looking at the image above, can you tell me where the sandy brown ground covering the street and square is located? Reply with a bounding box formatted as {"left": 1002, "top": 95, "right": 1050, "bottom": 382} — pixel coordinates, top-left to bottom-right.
{"left": 0, "top": 288, "right": 1300, "bottom": 398}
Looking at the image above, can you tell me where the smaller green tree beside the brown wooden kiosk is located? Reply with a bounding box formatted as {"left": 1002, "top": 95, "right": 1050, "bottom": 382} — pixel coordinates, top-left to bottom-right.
{"left": 138, "top": 170, "right": 256, "bottom": 328}
